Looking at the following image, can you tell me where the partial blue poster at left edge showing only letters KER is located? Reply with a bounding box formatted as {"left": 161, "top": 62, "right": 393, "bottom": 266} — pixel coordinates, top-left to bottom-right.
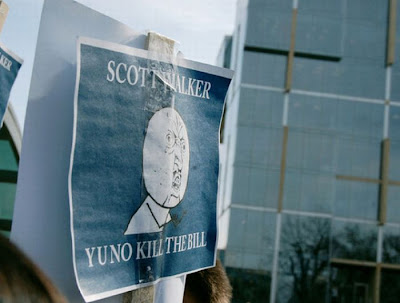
{"left": 0, "top": 43, "right": 23, "bottom": 126}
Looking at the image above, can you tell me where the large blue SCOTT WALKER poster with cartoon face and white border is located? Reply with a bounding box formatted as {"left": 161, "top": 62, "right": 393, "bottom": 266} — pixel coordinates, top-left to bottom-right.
{"left": 69, "top": 38, "right": 233, "bottom": 301}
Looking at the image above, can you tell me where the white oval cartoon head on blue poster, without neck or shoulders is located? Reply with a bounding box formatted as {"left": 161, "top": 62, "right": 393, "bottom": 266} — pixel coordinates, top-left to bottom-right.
{"left": 143, "top": 107, "right": 189, "bottom": 208}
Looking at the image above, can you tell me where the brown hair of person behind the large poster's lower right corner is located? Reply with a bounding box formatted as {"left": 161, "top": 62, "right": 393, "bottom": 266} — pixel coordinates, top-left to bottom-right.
{"left": 183, "top": 260, "right": 232, "bottom": 303}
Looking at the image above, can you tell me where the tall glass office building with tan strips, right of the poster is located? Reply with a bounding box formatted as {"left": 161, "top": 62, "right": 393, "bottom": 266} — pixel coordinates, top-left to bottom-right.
{"left": 219, "top": 0, "right": 400, "bottom": 303}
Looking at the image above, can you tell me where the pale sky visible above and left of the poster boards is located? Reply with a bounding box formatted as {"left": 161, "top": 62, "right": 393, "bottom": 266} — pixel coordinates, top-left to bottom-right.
{"left": 0, "top": 0, "right": 236, "bottom": 130}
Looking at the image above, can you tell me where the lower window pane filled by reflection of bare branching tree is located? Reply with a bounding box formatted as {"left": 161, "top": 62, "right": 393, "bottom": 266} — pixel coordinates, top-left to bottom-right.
{"left": 277, "top": 214, "right": 330, "bottom": 303}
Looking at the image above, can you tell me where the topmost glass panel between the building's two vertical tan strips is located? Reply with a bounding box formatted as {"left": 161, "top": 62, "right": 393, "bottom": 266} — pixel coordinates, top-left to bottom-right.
{"left": 293, "top": 0, "right": 388, "bottom": 99}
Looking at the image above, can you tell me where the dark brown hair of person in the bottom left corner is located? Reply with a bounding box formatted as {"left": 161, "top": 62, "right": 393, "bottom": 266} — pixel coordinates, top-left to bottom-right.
{"left": 0, "top": 234, "right": 67, "bottom": 303}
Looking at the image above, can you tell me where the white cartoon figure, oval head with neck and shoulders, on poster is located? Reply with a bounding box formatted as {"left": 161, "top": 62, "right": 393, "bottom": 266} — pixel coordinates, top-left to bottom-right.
{"left": 124, "top": 107, "right": 189, "bottom": 235}
